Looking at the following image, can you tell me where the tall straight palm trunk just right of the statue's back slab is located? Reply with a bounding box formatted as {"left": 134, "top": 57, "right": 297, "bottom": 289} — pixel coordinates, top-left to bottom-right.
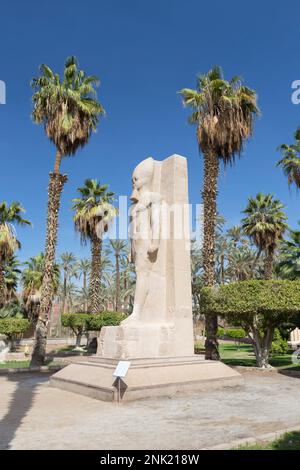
{"left": 202, "top": 152, "right": 220, "bottom": 360}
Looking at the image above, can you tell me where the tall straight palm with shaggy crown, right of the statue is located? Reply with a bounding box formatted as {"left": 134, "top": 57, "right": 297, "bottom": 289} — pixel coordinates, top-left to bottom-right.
{"left": 180, "top": 66, "right": 259, "bottom": 359}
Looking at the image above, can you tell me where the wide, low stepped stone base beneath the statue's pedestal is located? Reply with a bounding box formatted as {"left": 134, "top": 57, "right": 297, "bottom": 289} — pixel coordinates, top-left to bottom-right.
{"left": 50, "top": 355, "right": 243, "bottom": 402}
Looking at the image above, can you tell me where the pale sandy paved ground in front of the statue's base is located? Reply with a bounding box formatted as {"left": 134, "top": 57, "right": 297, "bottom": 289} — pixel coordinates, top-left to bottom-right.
{"left": 0, "top": 372, "right": 300, "bottom": 450}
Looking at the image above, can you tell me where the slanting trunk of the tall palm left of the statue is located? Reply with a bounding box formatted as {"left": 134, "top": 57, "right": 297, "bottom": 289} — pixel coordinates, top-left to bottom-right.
{"left": 31, "top": 169, "right": 67, "bottom": 365}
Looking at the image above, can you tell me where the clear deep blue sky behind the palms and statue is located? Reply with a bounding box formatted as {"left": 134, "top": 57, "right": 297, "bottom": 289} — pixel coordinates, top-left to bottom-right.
{"left": 0, "top": 0, "right": 300, "bottom": 260}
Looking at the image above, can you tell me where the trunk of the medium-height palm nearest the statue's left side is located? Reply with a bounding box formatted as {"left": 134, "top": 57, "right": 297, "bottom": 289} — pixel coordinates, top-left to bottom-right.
{"left": 90, "top": 234, "right": 102, "bottom": 313}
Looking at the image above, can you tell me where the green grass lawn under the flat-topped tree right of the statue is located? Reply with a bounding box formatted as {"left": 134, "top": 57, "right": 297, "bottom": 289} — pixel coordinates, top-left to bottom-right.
{"left": 195, "top": 341, "right": 300, "bottom": 371}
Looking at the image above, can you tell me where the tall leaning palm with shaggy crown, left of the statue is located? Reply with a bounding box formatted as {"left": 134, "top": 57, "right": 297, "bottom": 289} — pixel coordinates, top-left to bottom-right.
{"left": 31, "top": 56, "right": 104, "bottom": 365}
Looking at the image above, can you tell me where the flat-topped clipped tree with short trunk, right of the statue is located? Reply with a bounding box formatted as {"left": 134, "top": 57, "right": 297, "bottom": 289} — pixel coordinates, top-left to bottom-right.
{"left": 201, "top": 280, "right": 300, "bottom": 367}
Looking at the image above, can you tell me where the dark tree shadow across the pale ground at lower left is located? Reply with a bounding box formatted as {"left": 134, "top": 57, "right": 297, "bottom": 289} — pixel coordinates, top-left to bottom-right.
{"left": 0, "top": 372, "right": 49, "bottom": 450}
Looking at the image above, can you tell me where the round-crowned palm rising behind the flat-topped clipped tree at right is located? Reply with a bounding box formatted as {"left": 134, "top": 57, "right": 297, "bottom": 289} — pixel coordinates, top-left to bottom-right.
{"left": 242, "top": 193, "right": 287, "bottom": 280}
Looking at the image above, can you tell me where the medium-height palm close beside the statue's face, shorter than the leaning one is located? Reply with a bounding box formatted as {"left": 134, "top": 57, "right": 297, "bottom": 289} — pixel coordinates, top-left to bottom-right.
{"left": 73, "top": 179, "right": 117, "bottom": 313}
